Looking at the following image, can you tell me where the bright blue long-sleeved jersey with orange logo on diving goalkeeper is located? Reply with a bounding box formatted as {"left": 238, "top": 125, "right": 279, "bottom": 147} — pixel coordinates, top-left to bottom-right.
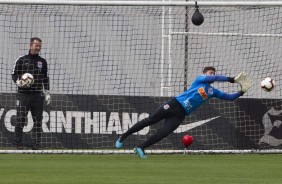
{"left": 176, "top": 75, "right": 241, "bottom": 114}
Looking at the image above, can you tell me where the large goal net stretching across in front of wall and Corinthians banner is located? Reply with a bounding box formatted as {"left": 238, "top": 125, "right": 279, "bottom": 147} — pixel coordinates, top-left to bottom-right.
{"left": 0, "top": 1, "right": 282, "bottom": 153}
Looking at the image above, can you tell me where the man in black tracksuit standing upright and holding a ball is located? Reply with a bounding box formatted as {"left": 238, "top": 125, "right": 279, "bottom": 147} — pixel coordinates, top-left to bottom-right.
{"left": 12, "top": 37, "right": 51, "bottom": 150}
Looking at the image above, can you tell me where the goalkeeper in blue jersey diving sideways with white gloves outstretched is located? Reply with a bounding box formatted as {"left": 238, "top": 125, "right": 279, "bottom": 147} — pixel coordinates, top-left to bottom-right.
{"left": 115, "top": 67, "right": 253, "bottom": 158}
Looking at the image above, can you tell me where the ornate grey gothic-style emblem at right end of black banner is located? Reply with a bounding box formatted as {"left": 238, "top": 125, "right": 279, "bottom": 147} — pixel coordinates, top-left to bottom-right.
{"left": 259, "top": 107, "right": 282, "bottom": 146}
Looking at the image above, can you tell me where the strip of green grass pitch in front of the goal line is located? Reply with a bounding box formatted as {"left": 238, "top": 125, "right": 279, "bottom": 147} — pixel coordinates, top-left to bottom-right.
{"left": 0, "top": 154, "right": 282, "bottom": 184}
